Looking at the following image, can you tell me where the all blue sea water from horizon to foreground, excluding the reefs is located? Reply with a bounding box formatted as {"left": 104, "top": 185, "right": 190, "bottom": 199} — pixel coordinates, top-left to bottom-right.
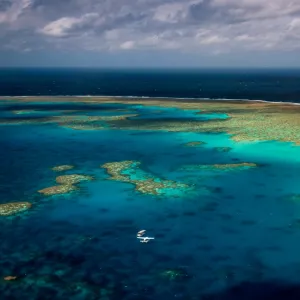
{"left": 0, "top": 69, "right": 300, "bottom": 300}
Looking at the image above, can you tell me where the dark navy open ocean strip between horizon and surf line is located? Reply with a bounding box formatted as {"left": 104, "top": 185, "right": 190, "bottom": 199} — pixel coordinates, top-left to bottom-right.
{"left": 0, "top": 68, "right": 300, "bottom": 102}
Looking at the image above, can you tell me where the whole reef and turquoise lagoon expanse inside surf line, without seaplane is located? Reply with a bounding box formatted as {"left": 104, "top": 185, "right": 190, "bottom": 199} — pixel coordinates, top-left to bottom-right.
{"left": 0, "top": 97, "right": 300, "bottom": 300}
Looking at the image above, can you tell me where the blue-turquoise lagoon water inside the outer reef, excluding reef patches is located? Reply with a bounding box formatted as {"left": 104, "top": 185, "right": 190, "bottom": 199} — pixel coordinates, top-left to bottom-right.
{"left": 0, "top": 103, "right": 300, "bottom": 300}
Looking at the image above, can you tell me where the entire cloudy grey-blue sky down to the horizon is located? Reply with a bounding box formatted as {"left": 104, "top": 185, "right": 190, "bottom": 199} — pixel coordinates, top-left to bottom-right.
{"left": 0, "top": 0, "right": 300, "bottom": 67}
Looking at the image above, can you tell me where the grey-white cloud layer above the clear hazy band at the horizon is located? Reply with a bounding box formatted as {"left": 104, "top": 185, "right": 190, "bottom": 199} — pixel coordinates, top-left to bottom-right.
{"left": 0, "top": 0, "right": 300, "bottom": 54}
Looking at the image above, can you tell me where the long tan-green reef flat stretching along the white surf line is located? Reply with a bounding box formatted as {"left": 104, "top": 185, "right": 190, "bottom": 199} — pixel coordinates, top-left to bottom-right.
{"left": 0, "top": 97, "right": 300, "bottom": 145}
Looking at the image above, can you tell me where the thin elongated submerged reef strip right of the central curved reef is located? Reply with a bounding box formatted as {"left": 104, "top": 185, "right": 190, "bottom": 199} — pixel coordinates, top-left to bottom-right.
{"left": 181, "top": 162, "right": 258, "bottom": 171}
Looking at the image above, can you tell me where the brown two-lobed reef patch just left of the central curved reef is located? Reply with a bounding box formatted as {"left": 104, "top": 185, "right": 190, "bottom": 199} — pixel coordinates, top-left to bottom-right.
{"left": 38, "top": 174, "right": 94, "bottom": 196}
